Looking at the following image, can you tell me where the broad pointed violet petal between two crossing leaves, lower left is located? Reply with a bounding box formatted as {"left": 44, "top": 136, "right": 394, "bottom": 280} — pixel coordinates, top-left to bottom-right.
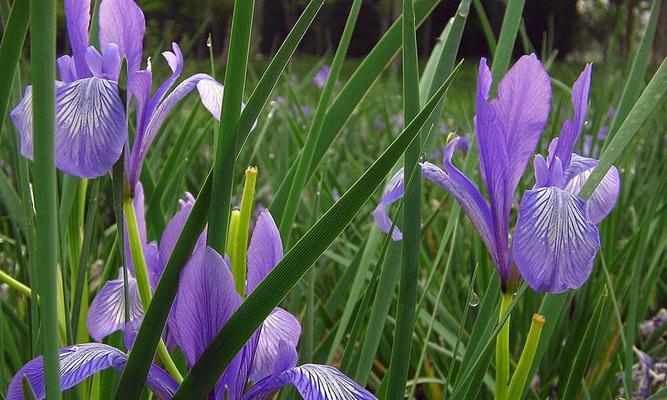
{"left": 172, "top": 246, "right": 241, "bottom": 366}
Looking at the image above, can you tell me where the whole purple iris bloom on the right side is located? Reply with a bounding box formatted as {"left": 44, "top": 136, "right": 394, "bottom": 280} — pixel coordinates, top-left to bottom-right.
{"left": 374, "top": 54, "right": 619, "bottom": 292}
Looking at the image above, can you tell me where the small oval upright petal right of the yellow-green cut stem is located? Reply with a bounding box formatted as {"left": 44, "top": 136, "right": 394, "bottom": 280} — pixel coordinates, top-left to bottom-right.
{"left": 247, "top": 209, "right": 283, "bottom": 294}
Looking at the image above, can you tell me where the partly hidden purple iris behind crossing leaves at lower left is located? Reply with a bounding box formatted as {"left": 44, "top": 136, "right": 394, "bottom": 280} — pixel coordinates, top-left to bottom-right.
{"left": 7, "top": 198, "right": 376, "bottom": 400}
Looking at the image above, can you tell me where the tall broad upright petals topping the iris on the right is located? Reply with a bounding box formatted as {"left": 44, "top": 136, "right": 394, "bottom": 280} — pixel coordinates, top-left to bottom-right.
{"left": 475, "top": 54, "right": 551, "bottom": 281}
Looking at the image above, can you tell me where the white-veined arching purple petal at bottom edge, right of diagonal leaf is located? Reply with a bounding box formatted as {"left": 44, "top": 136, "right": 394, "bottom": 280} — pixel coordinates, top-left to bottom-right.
{"left": 243, "top": 364, "right": 376, "bottom": 400}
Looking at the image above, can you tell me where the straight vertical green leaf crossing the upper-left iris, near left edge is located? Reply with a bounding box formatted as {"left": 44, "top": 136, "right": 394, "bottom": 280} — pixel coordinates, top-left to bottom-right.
{"left": 30, "top": 0, "right": 62, "bottom": 400}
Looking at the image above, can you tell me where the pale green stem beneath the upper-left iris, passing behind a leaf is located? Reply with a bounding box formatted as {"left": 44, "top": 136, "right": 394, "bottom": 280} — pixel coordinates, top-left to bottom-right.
{"left": 123, "top": 196, "right": 183, "bottom": 383}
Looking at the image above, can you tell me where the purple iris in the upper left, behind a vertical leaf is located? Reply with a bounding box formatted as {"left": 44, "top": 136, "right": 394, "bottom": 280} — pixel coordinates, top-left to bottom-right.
{"left": 10, "top": 0, "right": 227, "bottom": 183}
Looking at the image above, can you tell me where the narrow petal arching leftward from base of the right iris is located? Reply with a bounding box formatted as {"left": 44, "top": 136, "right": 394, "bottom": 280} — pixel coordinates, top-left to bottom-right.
{"left": 422, "top": 138, "right": 499, "bottom": 264}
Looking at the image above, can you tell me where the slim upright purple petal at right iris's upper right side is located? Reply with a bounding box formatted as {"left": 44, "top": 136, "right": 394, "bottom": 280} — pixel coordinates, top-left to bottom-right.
{"left": 554, "top": 64, "right": 592, "bottom": 169}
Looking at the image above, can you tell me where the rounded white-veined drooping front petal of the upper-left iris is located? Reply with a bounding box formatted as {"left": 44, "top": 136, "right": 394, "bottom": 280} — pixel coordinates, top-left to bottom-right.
{"left": 54, "top": 77, "right": 127, "bottom": 178}
